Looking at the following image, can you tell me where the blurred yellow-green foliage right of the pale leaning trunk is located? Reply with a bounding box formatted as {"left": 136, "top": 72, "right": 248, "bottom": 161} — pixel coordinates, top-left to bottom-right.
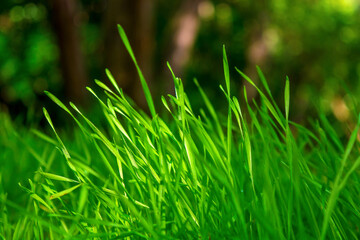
{"left": 187, "top": 0, "right": 360, "bottom": 122}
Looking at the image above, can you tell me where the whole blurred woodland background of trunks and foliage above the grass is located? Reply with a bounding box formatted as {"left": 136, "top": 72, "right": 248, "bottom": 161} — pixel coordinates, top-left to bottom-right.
{"left": 0, "top": 0, "right": 360, "bottom": 127}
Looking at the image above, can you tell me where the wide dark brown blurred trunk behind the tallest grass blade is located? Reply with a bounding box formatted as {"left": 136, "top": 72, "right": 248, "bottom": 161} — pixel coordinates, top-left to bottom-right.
{"left": 103, "top": 0, "right": 155, "bottom": 108}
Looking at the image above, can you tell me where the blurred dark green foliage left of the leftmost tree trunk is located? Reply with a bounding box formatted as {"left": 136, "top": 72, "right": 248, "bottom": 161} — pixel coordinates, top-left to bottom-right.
{"left": 0, "top": 1, "right": 61, "bottom": 106}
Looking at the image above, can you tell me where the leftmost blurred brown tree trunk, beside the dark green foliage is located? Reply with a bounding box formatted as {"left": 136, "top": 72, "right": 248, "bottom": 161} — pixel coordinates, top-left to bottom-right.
{"left": 51, "top": 0, "right": 88, "bottom": 105}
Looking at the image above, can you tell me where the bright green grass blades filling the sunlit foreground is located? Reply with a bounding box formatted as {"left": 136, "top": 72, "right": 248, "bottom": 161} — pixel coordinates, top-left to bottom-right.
{"left": 0, "top": 26, "right": 360, "bottom": 239}
